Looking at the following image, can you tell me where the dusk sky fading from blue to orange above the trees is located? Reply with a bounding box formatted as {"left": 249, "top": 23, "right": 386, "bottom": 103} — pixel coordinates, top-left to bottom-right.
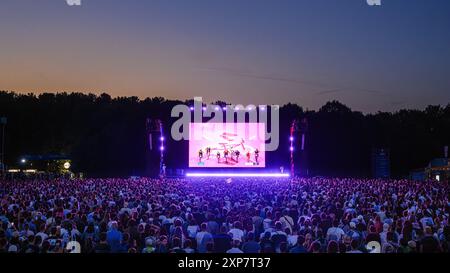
{"left": 0, "top": 0, "right": 450, "bottom": 112}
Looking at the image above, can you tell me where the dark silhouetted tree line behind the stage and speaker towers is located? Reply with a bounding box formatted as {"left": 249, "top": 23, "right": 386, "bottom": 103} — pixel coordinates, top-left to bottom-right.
{"left": 0, "top": 91, "right": 450, "bottom": 176}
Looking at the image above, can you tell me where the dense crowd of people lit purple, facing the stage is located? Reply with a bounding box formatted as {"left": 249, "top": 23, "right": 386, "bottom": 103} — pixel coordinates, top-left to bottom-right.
{"left": 0, "top": 178, "right": 450, "bottom": 253}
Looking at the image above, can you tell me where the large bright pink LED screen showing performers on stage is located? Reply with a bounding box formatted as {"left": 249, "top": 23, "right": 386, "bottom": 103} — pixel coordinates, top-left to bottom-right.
{"left": 189, "top": 123, "right": 266, "bottom": 168}
